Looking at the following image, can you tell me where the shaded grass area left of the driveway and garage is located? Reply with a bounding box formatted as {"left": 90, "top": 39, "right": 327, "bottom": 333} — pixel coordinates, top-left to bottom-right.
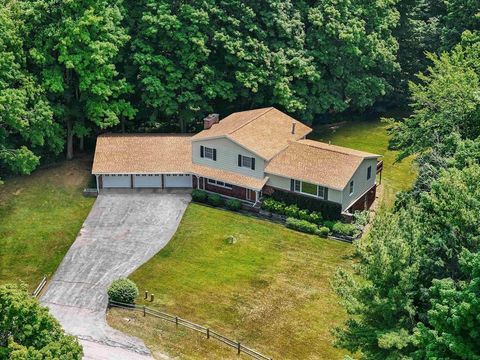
{"left": 0, "top": 159, "right": 94, "bottom": 289}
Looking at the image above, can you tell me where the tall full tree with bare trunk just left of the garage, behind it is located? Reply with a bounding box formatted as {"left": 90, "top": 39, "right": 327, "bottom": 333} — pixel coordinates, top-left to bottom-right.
{"left": 22, "top": 0, "right": 135, "bottom": 159}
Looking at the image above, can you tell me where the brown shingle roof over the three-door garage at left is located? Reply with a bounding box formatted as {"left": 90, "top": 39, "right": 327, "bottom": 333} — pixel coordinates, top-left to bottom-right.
{"left": 92, "top": 134, "right": 192, "bottom": 174}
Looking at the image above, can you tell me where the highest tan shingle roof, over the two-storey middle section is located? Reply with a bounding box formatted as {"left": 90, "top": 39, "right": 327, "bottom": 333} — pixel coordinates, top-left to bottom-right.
{"left": 192, "top": 107, "right": 312, "bottom": 160}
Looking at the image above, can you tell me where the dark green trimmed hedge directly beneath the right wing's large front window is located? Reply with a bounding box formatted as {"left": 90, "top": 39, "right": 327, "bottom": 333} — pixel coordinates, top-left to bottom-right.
{"left": 270, "top": 189, "right": 342, "bottom": 220}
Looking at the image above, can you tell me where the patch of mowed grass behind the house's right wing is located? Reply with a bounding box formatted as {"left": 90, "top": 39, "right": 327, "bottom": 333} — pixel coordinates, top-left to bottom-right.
{"left": 309, "top": 119, "right": 416, "bottom": 206}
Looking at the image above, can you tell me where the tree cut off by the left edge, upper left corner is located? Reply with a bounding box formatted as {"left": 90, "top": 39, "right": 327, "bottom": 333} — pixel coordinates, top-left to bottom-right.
{"left": 0, "top": 0, "right": 62, "bottom": 180}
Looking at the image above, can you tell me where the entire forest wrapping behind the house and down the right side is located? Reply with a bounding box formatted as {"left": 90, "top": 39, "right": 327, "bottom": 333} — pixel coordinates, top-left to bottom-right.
{"left": 0, "top": 0, "right": 480, "bottom": 360}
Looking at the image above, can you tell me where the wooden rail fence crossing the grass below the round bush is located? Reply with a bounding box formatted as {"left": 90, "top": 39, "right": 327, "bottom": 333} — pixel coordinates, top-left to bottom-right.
{"left": 109, "top": 300, "right": 272, "bottom": 360}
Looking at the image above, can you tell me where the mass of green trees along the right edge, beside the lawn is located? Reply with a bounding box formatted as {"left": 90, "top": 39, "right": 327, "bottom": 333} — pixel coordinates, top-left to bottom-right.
{"left": 334, "top": 19, "right": 480, "bottom": 360}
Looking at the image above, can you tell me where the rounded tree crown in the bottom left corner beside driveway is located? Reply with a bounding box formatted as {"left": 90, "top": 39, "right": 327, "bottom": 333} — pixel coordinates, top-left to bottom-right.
{"left": 0, "top": 284, "right": 83, "bottom": 360}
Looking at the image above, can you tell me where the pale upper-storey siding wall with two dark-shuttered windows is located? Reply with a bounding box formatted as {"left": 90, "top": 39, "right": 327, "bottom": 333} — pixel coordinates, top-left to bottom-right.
{"left": 192, "top": 138, "right": 265, "bottom": 179}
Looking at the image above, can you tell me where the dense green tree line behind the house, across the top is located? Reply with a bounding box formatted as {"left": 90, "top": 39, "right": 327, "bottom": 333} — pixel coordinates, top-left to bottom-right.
{"left": 0, "top": 0, "right": 472, "bottom": 176}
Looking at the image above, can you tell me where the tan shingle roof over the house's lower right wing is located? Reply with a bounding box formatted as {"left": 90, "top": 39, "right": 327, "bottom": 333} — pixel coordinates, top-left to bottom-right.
{"left": 265, "top": 140, "right": 380, "bottom": 190}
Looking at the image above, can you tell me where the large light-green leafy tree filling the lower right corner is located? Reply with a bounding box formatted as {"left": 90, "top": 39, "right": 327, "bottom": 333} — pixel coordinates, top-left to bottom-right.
{"left": 335, "top": 164, "right": 480, "bottom": 359}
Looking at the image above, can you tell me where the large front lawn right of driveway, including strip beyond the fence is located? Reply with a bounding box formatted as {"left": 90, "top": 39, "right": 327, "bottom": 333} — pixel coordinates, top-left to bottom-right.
{"left": 108, "top": 204, "right": 352, "bottom": 359}
